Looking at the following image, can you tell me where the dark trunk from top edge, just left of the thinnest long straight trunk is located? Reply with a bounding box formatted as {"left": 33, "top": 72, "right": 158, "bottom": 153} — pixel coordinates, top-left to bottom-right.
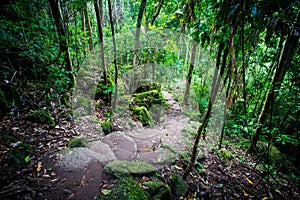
{"left": 94, "top": 0, "right": 108, "bottom": 85}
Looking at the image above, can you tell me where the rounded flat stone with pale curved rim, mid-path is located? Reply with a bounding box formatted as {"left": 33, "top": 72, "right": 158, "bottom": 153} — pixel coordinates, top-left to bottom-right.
{"left": 103, "top": 132, "right": 137, "bottom": 160}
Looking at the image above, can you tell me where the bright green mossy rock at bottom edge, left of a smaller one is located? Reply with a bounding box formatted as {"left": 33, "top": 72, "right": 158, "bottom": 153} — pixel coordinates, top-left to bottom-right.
{"left": 98, "top": 178, "right": 150, "bottom": 200}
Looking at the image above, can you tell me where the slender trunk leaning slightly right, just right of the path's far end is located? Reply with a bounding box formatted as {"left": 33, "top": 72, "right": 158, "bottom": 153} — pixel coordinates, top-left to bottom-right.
{"left": 184, "top": 43, "right": 197, "bottom": 105}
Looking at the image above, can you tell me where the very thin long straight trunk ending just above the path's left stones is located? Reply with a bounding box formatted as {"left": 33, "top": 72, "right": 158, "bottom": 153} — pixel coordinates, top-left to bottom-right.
{"left": 108, "top": 0, "right": 118, "bottom": 111}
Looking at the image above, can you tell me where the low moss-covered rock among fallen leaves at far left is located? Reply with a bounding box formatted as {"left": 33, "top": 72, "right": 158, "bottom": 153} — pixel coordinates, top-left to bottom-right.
{"left": 28, "top": 110, "right": 56, "bottom": 126}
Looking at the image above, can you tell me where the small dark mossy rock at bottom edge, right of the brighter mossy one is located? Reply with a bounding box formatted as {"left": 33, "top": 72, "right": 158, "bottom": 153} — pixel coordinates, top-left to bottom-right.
{"left": 143, "top": 181, "right": 172, "bottom": 200}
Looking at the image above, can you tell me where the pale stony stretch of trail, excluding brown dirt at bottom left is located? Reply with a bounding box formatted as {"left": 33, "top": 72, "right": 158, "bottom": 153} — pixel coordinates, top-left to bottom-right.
{"left": 58, "top": 91, "right": 189, "bottom": 169}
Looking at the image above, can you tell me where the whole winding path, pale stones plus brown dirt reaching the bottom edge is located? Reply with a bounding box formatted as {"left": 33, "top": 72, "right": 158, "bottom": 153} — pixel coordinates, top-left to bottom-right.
{"left": 39, "top": 92, "right": 189, "bottom": 200}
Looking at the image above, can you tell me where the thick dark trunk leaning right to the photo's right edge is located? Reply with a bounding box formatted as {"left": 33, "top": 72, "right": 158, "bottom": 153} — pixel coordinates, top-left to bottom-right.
{"left": 248, "top": 11, "right": 300, "bottom": 153}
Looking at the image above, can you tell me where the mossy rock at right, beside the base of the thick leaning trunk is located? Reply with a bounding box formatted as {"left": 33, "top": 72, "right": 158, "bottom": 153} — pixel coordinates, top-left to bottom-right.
{"left": 256, "top": 141, "right": 284, "bottom": 167}
